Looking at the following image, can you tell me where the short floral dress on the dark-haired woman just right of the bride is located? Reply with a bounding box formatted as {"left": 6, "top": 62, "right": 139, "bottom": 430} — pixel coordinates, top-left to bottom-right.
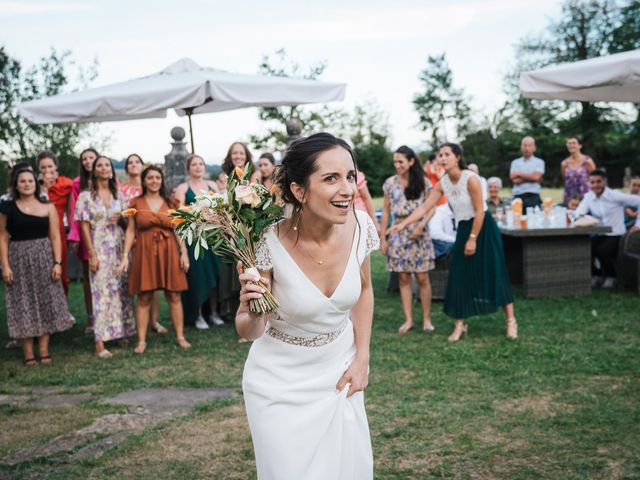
{"left": 382, "top": 175, "right": 436, "bottom": 273}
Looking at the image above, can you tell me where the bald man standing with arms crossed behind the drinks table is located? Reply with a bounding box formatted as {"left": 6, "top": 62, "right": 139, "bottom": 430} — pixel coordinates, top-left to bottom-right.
{"left": 509, "top": 137, "right": 544, "bottom": 211}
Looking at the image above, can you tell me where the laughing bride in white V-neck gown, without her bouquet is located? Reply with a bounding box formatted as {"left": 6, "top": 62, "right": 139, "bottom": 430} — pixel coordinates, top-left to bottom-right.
{"left": 236, "top": 133, "right": 379, "bottom": 480}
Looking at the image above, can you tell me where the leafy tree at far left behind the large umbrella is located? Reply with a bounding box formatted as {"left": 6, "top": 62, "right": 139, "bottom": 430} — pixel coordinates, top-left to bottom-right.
{"left": 0, "top": 46, "right": 104, "bottom": 186}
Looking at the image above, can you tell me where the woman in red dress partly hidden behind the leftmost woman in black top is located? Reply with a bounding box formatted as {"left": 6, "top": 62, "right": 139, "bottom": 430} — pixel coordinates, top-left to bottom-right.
{"left": 36, "top": 150, "right": 73, "bottom": 295}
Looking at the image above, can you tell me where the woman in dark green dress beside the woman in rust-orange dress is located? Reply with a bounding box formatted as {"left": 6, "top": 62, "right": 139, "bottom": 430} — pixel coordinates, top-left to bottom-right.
{"left": 175, "top": 155, "right": 224, "bottom": 330}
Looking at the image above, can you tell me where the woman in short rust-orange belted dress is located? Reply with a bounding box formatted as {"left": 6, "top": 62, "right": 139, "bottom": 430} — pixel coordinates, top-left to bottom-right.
{"left": 118, "top": 165, "right": 191, "bottom": 353}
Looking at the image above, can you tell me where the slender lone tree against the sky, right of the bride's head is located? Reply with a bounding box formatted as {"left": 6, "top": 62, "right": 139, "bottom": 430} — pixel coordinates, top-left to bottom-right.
{"left": 413, "top": 53, "right": 471, "bottom": 147}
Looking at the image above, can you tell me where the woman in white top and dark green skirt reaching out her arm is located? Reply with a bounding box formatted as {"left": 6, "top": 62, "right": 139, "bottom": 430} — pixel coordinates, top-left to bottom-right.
{"left": 393, "top": 143, "right": 518, "bottom": 342}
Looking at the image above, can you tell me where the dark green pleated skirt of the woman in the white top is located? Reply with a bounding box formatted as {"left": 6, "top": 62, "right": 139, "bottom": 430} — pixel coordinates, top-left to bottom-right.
{"left": 444, "top": 214, "right": 513, "bottom": 319}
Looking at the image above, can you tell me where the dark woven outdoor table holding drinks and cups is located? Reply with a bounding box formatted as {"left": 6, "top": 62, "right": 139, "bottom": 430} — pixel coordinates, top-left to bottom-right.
{"left": 500, "top": 226, "right": 611, "bottom": 298}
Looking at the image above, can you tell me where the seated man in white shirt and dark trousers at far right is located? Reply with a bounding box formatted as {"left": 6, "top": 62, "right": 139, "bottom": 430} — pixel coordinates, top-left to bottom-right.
{"left": 576, "top": 169, "right": 640, "bottom": 288}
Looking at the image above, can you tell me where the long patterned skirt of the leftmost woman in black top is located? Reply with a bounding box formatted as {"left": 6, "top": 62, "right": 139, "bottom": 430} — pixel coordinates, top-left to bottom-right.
{"left": 4, "top": 238, "right": 74, "bottom": 338}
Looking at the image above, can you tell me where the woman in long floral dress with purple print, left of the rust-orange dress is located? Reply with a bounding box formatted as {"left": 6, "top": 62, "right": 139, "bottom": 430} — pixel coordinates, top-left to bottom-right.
{"left": 75, "top": 156, "right": 135, "bottom": 358}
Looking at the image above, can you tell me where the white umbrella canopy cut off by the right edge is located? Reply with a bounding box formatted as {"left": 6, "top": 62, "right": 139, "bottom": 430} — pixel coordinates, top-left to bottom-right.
{"left": 519, "top": 49, "right": 640, "bottom": 103}
